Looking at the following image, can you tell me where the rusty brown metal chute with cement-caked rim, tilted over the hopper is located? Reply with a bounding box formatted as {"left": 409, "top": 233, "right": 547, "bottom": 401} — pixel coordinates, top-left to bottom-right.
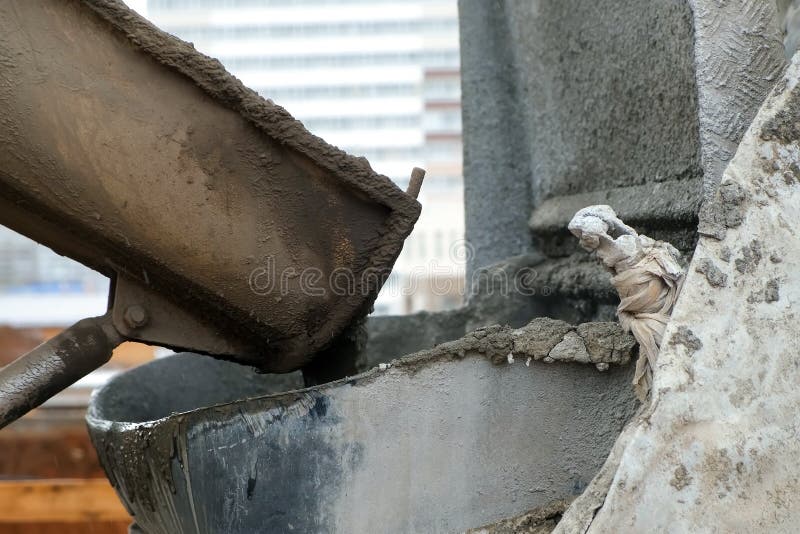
{"left": 0, "top": 0, "right": 420, "bottom": 430}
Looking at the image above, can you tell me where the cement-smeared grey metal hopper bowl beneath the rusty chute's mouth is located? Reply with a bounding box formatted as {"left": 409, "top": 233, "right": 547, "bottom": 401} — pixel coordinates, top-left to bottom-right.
{"left": 87, "top": 343, "right": 634, "bottom": 534}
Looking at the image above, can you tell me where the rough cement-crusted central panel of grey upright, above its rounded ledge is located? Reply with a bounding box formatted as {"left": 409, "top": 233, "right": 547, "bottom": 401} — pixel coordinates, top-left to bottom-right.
{"left": 506, "top": 0, "right": 702, "bottom": 205}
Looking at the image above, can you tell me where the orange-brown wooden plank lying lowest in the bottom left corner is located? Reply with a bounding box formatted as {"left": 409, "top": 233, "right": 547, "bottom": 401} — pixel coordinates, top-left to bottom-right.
{"left": 0, "top": 479, "right": 131, "bottom": 524}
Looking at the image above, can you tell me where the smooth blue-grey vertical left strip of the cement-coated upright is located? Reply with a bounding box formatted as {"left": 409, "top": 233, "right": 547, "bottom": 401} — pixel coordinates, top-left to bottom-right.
{"left": 459, "top": 0, "right": 533, "bottom": 279}
